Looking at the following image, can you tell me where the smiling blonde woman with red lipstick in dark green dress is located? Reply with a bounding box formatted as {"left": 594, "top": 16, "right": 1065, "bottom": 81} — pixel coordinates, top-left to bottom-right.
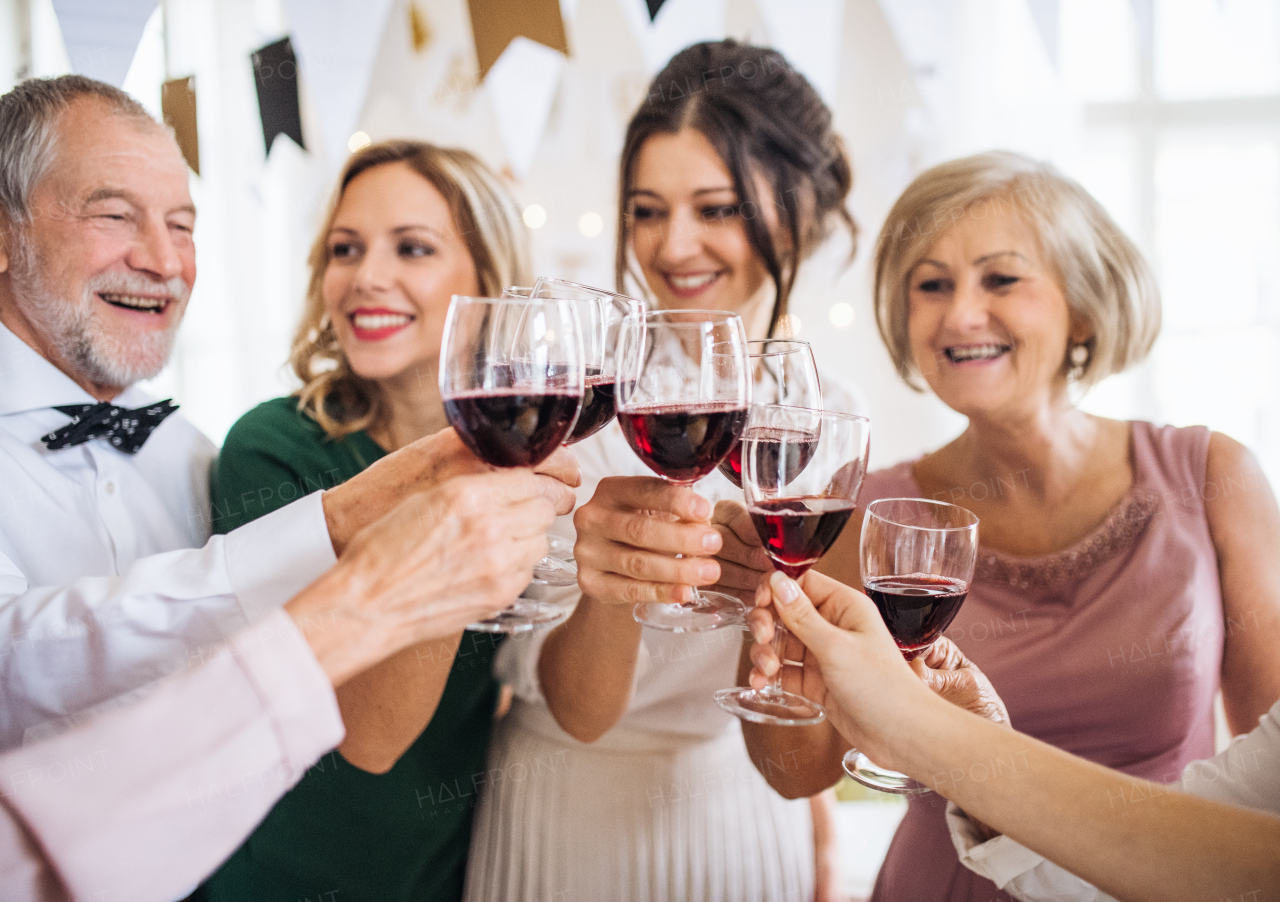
{"left": 200, "top": 141, "right": 554, "bottom": 902}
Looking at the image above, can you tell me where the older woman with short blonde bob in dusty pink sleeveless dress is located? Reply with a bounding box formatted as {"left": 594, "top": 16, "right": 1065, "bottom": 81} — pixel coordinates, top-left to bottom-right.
{"left": 723, "top": 154, "right": 1280, "bottom": 902}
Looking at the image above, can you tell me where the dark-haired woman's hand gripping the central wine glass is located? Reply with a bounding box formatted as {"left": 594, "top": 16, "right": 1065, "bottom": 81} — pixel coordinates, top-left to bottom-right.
{"left": 573, "top": 476, "right": 722, "bottom": 604}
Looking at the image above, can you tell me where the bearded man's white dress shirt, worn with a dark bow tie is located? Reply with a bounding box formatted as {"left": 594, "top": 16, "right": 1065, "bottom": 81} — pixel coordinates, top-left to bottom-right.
{"left": 0, "top": 319, "right": 334, "bottom": 750}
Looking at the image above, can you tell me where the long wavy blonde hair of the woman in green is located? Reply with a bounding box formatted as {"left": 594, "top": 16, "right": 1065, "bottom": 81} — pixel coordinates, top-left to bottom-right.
{"left": 289, "top": 141, "right": 532, "bottom": 439}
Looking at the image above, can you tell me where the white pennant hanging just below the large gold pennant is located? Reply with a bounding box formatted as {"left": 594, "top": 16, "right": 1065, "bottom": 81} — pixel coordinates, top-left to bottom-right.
{"left": 484, "top": 37, "right": 564, "bottom": 178}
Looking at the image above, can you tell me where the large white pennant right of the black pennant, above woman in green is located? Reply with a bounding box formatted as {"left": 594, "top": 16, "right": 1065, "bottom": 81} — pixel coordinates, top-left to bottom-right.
{"left": 284, "top": 0, "right": 393, "bottom": 166}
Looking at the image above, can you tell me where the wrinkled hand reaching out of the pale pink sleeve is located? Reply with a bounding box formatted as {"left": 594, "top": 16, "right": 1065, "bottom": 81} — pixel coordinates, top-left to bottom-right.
{"left": 299, "top": 470, "right": 556, "bottom": 686}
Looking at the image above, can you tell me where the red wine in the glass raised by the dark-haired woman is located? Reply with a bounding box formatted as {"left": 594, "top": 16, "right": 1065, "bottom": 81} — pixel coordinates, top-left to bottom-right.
{"left": 618, "top": 402, "right": 748, "bottom": 485}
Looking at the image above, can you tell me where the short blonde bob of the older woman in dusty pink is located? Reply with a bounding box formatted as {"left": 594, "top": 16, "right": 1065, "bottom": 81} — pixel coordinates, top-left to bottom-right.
{"left": 874, "top": 151, "right": 1161, "bottom": 390}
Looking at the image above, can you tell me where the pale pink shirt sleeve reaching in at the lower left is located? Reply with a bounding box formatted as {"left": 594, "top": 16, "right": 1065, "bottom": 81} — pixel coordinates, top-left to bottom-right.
{"left": 0, "top": 610, "right": 343, "bottom": 902}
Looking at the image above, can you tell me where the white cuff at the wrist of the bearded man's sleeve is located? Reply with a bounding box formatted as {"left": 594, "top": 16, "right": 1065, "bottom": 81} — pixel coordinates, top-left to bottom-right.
{"left": 225, "top": 491, "right": 338, "bottom": 623}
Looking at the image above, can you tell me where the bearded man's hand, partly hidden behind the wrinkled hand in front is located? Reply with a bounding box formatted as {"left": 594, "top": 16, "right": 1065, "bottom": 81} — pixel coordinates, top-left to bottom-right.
{"left": 324, "top": 429, "right": 581, "bottom": 557}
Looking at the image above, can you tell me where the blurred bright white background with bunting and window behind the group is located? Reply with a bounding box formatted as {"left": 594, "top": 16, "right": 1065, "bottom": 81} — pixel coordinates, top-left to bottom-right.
{"left": 0, "top": 0, "right": 1280, "bottom": 892}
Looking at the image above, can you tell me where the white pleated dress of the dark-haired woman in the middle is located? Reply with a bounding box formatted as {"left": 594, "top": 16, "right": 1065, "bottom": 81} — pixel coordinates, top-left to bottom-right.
{"left": 465, "top": 374, "right": 865, "bottom": 902}
